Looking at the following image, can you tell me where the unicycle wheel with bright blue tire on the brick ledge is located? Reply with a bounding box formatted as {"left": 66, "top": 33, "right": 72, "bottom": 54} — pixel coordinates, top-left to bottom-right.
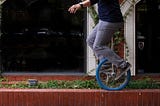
{"left": 96, "top": 59, "right": 131, "bottom": 91}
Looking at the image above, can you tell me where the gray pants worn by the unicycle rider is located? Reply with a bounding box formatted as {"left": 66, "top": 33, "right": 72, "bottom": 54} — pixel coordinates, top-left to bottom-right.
{"left": 87, "top": 20, "right": 124, "bottom": 67}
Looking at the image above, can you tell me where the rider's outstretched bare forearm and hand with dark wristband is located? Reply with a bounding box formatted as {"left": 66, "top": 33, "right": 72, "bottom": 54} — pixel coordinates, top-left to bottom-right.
{"left": 68, "top": 0, "right": 91, "bottom": 13}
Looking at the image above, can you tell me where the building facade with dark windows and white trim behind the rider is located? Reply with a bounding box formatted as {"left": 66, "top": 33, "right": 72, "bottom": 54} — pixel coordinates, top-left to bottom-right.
{"left": 1, "top": 0, "right": 160, "bottom": 75}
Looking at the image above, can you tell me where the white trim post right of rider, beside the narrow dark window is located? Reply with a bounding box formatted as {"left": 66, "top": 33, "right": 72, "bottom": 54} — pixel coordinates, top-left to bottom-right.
{"left": 121, "top": 0, "right": 141, "bottom": 75}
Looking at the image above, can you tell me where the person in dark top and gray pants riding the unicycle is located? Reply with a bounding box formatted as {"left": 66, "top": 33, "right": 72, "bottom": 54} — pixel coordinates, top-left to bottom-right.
{"left": 68, "top": 0, "right": 131, "bottom": 78}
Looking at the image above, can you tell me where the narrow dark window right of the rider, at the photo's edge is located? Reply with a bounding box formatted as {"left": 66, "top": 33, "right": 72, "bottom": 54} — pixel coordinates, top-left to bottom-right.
{"left": 136, "top": 0, "right": 160, "bottom": 73}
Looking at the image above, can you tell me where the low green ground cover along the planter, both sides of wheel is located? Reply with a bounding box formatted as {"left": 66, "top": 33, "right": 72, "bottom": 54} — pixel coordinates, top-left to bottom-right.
{"left": 0, "top": 77, "right": 160, "bottom": 89}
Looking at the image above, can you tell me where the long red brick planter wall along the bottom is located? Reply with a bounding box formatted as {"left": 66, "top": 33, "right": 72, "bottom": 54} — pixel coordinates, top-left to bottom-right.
{"left": 0, "top": 89, "right": 160, "bottom": 106}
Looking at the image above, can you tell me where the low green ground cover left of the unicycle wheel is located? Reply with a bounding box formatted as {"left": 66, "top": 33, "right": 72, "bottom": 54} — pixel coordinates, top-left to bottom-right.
{"left": 0, "top": 79, "right": 99, "bottom": 89}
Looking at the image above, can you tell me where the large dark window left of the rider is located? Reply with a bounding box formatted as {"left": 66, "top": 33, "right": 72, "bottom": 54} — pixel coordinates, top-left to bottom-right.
{"left": 1, "top": 0, "right": 85, "bottom": 72}
